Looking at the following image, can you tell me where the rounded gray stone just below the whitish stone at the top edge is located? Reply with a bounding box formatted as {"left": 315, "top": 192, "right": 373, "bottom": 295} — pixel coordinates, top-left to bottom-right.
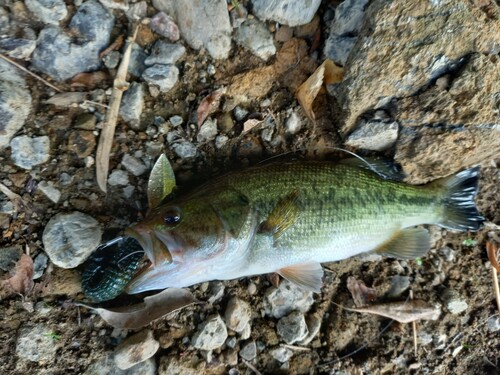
{"left": 235, "top": 18, "right": 276, "bottom": 61}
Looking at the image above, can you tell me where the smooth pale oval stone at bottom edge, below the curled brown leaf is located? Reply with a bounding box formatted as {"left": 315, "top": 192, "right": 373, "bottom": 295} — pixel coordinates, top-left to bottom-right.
{"left": 114, "top": 329, "right": 160, "bottom": 370}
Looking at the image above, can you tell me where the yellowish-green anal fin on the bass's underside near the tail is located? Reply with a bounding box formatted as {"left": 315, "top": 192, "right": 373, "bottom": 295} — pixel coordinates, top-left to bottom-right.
{"left": 374, "top": 228, "right": 431, "bottom": 259}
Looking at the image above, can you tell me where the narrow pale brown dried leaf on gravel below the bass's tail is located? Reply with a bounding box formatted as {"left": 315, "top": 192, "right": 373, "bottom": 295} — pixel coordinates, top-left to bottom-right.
{"left": 338, "top": 299, "right": 441, "bottom": 323}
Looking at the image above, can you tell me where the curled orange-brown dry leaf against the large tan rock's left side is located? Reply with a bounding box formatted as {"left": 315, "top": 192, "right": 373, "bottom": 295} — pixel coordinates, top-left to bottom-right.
{"left": 295, "top": 59, "right": 344, "bottom": 121}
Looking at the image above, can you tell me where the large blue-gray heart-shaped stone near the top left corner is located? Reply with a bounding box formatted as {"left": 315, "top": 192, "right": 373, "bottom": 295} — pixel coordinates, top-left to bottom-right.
{"left": 32, "top": 0, "right": 114, "bottom": 81}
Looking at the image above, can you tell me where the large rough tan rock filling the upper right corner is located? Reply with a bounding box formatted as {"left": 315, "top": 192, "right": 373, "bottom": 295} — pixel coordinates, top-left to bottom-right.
{"left": 337, "top": 0, "right": 500, "bottom": 182}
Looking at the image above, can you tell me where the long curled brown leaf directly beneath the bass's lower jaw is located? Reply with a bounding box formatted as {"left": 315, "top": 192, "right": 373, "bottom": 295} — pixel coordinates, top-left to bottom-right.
{"left": 77, "top": 288, "right": 196, "bottom": 329}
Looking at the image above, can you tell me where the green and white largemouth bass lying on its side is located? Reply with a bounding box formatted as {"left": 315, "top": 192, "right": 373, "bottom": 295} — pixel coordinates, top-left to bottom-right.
{"left": 125, "top": 159, "right": 485, "bottom": 294}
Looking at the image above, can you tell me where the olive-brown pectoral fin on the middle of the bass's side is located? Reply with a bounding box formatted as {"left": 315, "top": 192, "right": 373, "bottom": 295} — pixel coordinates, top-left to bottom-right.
{"left": 259, "top": 190, "right": 300, "bottom": 241}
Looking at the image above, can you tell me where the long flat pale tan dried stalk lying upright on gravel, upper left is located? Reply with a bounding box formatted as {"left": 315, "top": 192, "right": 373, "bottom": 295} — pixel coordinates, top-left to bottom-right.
{"left": 95, "top": 26, "right": 139, "bottom": 193}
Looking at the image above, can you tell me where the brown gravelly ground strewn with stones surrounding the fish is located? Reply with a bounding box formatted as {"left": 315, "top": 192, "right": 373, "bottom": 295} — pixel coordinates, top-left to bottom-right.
{"left": 0, "top": 0, "right": 500, "bottom": 375}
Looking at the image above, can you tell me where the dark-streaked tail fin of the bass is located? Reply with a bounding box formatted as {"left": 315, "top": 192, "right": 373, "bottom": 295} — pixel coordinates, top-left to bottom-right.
{"left": 434, "top": 167, "right": 484, "bottom": 231}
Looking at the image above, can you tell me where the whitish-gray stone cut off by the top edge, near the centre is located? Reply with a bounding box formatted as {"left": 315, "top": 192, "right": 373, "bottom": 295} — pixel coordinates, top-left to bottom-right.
{"left": 252, "top": 0, "right": 321, "bottom": 26}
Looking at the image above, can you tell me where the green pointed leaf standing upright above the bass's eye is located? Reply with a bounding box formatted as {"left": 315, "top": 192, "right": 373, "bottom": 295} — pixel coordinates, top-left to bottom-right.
{"left": 148, "top": 154, "right": 175, "bottom": 210}
